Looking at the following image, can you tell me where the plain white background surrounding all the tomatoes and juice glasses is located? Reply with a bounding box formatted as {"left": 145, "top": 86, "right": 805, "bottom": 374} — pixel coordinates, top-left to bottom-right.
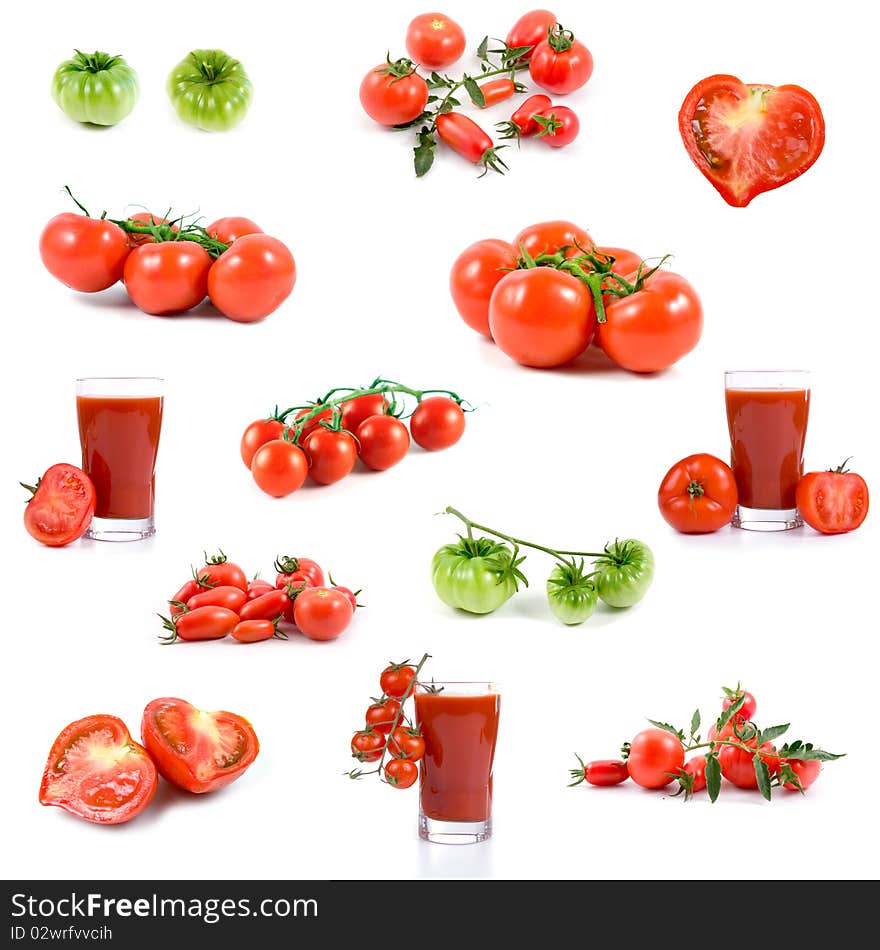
{"left": 0, "top": 0, "right": 880, "bottom": 879}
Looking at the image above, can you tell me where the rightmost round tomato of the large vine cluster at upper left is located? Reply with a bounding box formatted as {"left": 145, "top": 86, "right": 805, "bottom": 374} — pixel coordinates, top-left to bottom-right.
{"left": 208, "top": 234, "right": 296, "bottom": 323}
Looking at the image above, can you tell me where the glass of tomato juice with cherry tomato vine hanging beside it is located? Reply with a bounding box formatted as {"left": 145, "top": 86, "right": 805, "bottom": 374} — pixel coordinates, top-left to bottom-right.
{"left": 414, "top": 682, "right": 501, "bottom": 844}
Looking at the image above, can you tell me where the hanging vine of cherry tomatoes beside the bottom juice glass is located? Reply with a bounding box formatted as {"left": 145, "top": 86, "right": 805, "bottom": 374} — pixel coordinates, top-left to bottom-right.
{"left": 349, "top": 661, "right": 425, "bottom": 788}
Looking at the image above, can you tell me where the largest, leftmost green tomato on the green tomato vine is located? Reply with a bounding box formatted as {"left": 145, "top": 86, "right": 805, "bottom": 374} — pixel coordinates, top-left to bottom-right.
{"left": 431, "top": 538, "right": 528, "bottom": 614}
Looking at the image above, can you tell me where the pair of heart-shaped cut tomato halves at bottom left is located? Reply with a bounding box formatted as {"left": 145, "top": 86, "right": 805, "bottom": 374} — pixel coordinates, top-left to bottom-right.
{"left": 40, "top": 697, "right": 260, "bottom": 825}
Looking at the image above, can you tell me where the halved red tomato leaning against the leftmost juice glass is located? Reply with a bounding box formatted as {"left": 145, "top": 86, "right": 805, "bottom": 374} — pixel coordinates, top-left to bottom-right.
{"left": 21, "top": 462, "right": 95, "bottom": 548}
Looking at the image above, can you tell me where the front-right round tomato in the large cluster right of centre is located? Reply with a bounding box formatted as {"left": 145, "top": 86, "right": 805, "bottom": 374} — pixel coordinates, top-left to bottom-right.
{"left": 596, "top": 270, "right": 703, "bottom": 373}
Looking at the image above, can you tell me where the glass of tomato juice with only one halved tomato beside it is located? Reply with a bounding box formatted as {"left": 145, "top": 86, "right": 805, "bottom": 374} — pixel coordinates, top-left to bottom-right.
{"left": 76, "top": 376, "right": 164, "bottom": 541}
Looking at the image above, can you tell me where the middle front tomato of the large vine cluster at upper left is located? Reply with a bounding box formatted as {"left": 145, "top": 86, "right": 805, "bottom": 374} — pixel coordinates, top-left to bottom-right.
{"left": 124, "top": 241, "right": 212, "bottom": 316}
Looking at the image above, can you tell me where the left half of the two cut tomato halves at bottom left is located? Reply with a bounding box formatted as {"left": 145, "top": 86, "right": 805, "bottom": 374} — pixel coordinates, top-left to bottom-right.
{"left": 40, "top": 716, "right": 158, "bottom": 825}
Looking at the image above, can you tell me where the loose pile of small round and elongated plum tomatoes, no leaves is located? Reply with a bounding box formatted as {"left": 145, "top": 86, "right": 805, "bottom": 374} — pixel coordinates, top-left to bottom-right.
{"left": 160, "top": 551, "right": 360, "bottom": 643}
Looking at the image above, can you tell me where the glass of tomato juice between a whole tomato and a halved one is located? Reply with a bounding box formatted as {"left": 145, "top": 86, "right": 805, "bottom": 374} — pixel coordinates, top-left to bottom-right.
{"left": 724, "top": 370, "right": 810, "bottom": 531}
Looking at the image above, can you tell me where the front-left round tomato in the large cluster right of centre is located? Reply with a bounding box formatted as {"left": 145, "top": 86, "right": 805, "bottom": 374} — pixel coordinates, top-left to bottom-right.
{"left": 489, "top": 267, "right": 596, "bottom": 367}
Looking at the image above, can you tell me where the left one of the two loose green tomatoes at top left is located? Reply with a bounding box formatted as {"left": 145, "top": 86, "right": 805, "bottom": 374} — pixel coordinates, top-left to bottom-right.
{"left": 52, "top": 50, "right": 140, "bottom": 125}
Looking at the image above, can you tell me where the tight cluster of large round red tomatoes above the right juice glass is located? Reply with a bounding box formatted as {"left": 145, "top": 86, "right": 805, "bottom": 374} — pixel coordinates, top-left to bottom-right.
{"left": 449, "top": 221, "right": 703, "bottom": 373}
